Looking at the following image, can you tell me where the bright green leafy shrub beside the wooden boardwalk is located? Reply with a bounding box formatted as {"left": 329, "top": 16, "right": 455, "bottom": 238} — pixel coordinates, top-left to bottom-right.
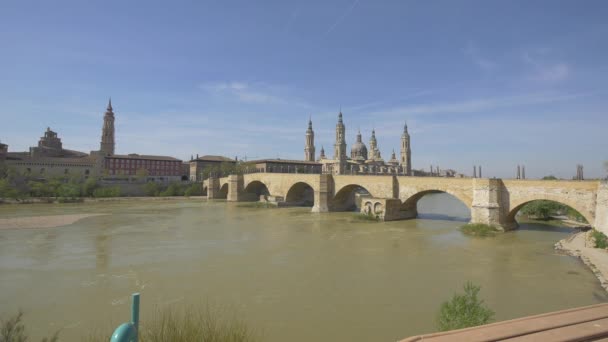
{"left": 437, "top": 282, "right": 494, "bottom": 331}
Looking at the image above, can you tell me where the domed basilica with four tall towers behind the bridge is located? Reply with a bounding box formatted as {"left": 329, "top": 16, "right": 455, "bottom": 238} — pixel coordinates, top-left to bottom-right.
{"left": 304, "top": 112, "right": 412, "bottom": 176}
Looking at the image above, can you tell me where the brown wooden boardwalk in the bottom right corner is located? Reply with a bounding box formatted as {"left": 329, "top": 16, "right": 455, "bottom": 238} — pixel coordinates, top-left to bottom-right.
{"left": 401, "top": 303, "right": 608, "bottom": 342}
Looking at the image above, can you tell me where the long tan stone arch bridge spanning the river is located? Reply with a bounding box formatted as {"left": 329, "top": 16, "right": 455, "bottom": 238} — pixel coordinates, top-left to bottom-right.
{"left": 203, "top": 173, "right": 608, "bottom": 234}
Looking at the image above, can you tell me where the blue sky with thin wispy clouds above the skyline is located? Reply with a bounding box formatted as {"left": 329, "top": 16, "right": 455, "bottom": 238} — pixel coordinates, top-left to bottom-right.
{"left": 0, "top": 0, "right": 608, "bottom": 178}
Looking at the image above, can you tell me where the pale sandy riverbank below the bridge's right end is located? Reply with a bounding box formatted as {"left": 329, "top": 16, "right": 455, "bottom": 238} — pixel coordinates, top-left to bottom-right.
{"left": 555, "top": 230, "right": 608, "bottom": 291}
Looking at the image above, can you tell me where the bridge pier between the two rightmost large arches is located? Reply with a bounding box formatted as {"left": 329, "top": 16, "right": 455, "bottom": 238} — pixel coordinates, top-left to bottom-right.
{"left": 471, "top": 178, "right": 517, "bottom": 231}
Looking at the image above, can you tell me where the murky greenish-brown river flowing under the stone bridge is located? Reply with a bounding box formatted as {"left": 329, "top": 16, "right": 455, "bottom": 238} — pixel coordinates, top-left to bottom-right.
{"left": 0, "top": 194, "right": 608, "bottom": 341}
